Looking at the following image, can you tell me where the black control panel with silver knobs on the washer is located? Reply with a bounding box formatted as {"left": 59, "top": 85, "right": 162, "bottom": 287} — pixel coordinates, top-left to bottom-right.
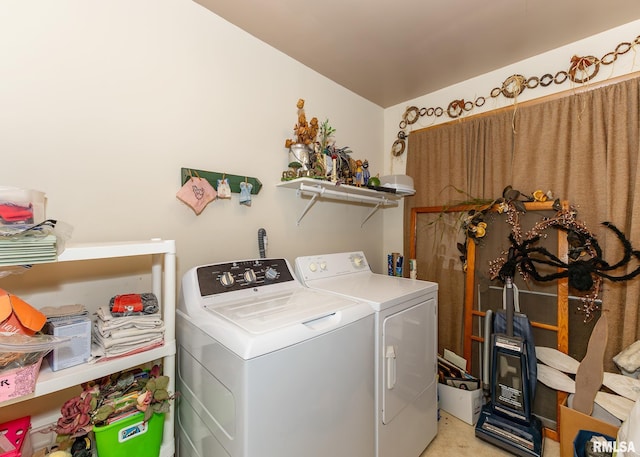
{"left": 197, "top": 259, "right": 295, "bottom": 297}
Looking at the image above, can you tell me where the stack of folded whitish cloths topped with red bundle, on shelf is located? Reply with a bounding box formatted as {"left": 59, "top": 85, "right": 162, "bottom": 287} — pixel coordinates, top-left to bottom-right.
{"left": 92, "top": 293, "right": 164, "bottom": 360}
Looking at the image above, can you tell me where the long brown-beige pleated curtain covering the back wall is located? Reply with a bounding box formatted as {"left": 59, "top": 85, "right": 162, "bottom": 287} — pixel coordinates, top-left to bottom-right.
{"left": 404, "top": 78, "right": 640, "bottom": 368}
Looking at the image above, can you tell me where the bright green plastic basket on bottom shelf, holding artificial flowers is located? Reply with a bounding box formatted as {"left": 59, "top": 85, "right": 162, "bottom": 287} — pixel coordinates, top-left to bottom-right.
{"left": 93, "top": 413, "right": 164, "bottom": 457}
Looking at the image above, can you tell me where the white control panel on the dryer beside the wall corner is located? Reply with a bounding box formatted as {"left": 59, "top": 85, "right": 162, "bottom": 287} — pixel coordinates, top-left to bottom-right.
{"left": 296, "top": 251, "right": 370, "bottom": 281}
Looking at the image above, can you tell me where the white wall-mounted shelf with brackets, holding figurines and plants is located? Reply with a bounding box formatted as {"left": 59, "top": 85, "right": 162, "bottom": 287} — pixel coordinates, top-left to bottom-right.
{"left": 277, "top": 178, "right": 402, "bottom": 226}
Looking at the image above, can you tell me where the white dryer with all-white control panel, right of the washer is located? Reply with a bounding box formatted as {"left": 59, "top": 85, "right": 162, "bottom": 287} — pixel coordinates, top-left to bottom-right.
{"left": 295, "top": 252, "right": 438, "bottom": 457}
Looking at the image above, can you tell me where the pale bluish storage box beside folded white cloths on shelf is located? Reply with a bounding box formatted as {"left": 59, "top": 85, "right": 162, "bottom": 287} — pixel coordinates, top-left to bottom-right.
{"left": 43, "top": 316, "right": 91, "bottom": 371}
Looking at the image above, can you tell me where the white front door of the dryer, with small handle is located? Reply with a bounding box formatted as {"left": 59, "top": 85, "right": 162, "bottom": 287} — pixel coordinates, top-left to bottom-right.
{"left": 380, "top": 300, "right": 436, "bottom": 424}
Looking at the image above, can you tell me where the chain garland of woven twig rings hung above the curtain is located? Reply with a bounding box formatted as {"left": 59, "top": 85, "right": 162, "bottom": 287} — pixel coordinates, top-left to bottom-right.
{"left": 391, "top": 35, "right": 640, "bottom": 156}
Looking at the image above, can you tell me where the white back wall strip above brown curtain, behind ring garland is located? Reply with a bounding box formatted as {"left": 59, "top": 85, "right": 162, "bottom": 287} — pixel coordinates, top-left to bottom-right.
{"left": 383, "top": 21, "right": 640, "bottom": 252}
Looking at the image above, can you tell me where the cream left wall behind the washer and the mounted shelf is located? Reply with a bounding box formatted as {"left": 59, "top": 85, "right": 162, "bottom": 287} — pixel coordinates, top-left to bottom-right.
{"left": 0, "top": 0, "right": 384, "bottom": 274}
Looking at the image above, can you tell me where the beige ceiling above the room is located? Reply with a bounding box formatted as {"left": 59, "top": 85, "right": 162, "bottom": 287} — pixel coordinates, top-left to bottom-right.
{"left": 195, "top": 0, "right": 640, "bottom": 108}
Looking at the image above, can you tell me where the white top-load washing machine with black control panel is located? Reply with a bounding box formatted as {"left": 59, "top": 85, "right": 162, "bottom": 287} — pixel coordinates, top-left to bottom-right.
{"left": 176, "top": 259, "right": 375, "bottom": 457}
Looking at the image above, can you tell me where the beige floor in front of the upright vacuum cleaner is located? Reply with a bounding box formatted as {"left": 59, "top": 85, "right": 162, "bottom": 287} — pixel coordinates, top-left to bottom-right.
{"left": 421, "top": 410, "right": 560, "bottom": 457}
